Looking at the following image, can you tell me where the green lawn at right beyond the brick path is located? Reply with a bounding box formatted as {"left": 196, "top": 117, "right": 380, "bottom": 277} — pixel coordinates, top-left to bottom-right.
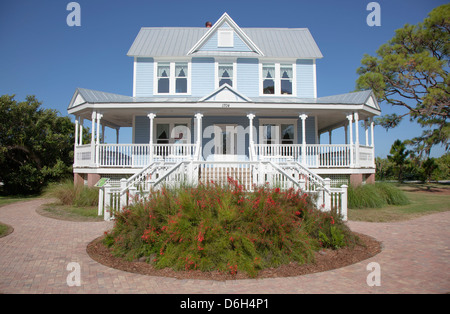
{"left": 348, "top": 184, "right": 450, "bottom": 222}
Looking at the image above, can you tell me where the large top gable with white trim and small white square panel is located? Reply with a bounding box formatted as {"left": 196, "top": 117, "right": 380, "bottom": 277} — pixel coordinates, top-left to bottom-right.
{"left": 188, "top": 13, "right": 263, "bottom": 55}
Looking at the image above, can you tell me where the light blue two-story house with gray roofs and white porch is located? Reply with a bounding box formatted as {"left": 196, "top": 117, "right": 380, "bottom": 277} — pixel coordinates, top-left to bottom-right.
{"left": 68, "top": 13, "right": 380, "bottom": 195}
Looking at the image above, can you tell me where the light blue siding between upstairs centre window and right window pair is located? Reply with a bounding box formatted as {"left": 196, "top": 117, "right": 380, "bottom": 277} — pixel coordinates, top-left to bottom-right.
{"left": 236, "top": 58, "right": 259, "bottom": 97}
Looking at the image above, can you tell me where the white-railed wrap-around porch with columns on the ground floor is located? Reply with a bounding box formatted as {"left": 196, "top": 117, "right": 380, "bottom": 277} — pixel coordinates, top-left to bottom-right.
{"left": 74, "top": 110, "right": 375, "bottom": 170}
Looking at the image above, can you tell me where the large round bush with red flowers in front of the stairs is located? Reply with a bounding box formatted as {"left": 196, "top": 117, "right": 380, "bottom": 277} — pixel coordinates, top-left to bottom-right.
{"left": 104, "top": 180, "right": 355, "bottom": 276}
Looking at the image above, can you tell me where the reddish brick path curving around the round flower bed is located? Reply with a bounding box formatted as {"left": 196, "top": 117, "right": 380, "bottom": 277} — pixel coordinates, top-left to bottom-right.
{"left": 0, "top": 199, "right": 450, "bottom": 294}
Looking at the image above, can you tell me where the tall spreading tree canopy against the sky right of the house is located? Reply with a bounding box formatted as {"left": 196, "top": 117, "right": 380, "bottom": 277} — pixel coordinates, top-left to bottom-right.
{"left": 356, "top": 4, "right": 450, "bottom": 155}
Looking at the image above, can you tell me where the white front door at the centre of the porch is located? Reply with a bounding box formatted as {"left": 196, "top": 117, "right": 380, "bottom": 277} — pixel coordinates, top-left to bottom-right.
{"left": 214, "top": 124, "right": 237, "bottom": 161}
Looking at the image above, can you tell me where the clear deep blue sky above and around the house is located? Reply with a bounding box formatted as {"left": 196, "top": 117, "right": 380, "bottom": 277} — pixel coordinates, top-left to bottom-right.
{"left": 0, "top": 0, "right": 446, "bottom": 157}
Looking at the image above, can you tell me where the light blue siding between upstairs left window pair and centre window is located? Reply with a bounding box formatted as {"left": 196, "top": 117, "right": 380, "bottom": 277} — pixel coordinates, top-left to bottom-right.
{"left": 191, "top": 58, "right": 215, "bottom": 97}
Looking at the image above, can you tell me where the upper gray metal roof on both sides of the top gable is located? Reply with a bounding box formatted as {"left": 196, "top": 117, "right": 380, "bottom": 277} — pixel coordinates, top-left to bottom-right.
{"left": 127, "top": 27, "right": 323, "bottom": 58}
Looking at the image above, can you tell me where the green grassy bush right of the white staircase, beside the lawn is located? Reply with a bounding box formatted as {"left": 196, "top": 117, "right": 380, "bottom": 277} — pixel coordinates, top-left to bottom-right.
{"left": 348, "top": 182, "right": 409, "bottom": 208}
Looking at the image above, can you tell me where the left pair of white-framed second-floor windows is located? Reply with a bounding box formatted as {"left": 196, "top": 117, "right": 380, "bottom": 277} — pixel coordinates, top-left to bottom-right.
{"left": 156, "top": 62, "right": 189, "bottom": 94}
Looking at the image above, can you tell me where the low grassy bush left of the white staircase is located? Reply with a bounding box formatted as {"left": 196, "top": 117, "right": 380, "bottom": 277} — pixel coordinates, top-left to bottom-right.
{"left": 44, "top": 180, "right": 98, "bottom": 207}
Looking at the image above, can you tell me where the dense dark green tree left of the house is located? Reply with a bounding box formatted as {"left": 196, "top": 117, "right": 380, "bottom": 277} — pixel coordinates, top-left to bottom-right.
{"left": 0, "top": 95, "right": 74, "bottom": 194}
